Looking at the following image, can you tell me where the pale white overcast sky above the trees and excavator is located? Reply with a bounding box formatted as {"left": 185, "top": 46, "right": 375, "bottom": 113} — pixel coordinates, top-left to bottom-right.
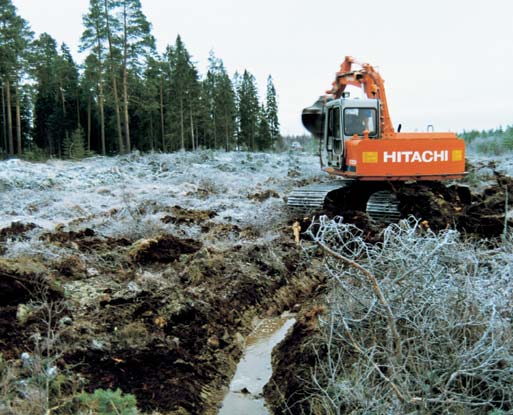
{"left": 13, "top": 0, "right": 513, "bottom": 135}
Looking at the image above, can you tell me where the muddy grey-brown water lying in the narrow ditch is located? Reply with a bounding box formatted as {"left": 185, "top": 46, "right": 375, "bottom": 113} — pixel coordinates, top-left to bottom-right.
{"left": 219, "top": 313, "right": 295, "bottom": 415}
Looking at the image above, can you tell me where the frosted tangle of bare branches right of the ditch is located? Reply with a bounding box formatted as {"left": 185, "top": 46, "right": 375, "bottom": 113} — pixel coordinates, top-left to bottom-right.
{"left": 308, "top": 217, "right": 513, "bottom": 414}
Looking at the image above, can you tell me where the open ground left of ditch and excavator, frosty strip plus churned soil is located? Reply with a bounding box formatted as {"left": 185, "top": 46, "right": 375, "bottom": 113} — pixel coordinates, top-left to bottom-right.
{"left": 0, "top": 151, "right": 324, "bottom": 413}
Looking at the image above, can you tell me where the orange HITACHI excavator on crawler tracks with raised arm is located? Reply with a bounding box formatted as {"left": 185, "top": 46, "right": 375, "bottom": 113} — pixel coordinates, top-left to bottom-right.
{"left": 287, "top": 56, "right": 465, "bottom": 221}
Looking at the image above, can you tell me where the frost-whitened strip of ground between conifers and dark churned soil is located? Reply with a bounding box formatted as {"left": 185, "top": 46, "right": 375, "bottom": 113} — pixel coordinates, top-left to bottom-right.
{"left": 0, "top": 151, "right": 321, "bottom": 256}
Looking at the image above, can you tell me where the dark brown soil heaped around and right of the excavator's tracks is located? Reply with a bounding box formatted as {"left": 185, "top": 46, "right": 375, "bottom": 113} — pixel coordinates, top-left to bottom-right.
{"left": 314, "top": 172, "right": 513, "bottom": 240}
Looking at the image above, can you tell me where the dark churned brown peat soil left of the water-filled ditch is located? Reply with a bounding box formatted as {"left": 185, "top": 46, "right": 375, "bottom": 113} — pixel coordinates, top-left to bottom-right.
{"left": 0, "top": 216, "right": 321, "bottom": 414}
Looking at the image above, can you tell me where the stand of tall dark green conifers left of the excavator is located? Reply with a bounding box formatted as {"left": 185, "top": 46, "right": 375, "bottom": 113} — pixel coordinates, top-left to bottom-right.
{"left": 0, "top": 0, "right": 280, "bottom": 158}
